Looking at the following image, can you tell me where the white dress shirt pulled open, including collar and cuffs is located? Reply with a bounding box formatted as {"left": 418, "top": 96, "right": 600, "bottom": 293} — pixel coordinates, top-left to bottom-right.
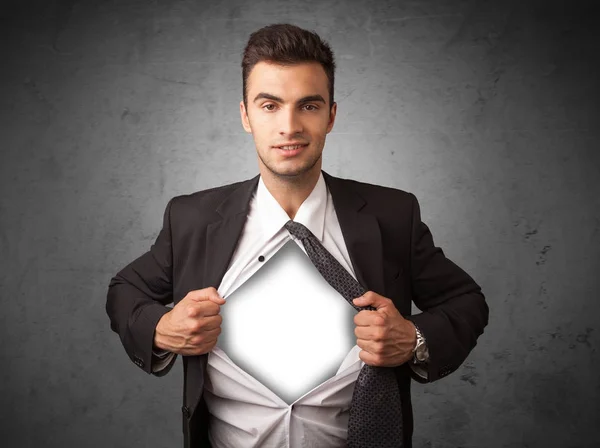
{"left": 153, "top": 173, "right": 426, "bottom": 448}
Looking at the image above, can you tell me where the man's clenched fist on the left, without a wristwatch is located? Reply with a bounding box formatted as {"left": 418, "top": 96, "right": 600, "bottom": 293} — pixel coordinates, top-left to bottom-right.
{"left": 154, "top": 286, "right": 225, "bottom": 355}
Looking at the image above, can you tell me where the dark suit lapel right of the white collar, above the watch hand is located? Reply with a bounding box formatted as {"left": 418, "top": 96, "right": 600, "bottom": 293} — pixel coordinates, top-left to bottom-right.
{"left": 323, "top": 171, "right": 385, "bottom": 295}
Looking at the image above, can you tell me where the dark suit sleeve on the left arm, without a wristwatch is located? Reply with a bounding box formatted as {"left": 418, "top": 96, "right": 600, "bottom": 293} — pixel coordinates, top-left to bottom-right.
{"left": 106, "top": 198, "right": 176, "bottom": 376}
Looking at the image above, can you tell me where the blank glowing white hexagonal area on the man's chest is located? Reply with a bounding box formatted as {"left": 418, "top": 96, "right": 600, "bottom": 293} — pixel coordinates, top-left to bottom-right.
{"left": 217, "top": 241, "right": 356, "bottom": 403}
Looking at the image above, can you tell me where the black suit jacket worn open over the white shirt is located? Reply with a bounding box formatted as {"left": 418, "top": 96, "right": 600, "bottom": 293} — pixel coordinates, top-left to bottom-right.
{"left": 106, "top": 171, "right": 489, "bottom": 448}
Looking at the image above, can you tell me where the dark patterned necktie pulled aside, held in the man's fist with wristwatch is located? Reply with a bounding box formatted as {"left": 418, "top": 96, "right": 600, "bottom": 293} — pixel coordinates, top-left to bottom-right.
{"left": 285, "top": 220, "right": 403, "bottom": 448}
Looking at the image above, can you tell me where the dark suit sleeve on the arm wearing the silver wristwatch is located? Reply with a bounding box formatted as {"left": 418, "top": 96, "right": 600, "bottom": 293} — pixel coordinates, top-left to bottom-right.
{"left": 406, "top": 193, "right": 489, "bottom": 383}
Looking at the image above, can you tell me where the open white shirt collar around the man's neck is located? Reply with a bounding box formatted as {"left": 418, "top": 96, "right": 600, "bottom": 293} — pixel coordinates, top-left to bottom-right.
{"left": 256, "top": 172, "right": 327, "bottom": 242}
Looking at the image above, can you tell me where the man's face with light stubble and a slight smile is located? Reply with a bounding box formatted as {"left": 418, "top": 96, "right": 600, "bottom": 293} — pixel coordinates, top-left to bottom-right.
{"left": 240, "top": 62, "right": 337, "bottom": 179}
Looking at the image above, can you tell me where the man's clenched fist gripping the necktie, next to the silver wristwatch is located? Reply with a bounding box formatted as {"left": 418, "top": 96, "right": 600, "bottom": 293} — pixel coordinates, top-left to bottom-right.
{"left": 353, "top": 291, "right": 417, "bottom": 367}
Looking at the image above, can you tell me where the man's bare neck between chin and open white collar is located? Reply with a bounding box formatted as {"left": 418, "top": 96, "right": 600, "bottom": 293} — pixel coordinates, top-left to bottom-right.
{"left": 260, "top": 166, "right": 321, "bottom": 219}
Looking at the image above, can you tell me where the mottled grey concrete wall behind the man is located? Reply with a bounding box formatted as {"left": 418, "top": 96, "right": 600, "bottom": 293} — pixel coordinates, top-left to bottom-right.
{"left": 0, "top": 0, "right": 600, "bottom": 448}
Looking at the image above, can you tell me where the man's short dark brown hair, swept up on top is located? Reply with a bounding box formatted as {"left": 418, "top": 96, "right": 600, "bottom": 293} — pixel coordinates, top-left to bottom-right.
{"left": 242, "top": 23, "right": 335, "bottom": 109}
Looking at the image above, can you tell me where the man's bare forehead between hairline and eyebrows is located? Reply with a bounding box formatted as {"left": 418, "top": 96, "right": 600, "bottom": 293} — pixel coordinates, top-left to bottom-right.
{"left": 248, "top": 61, "right": 328, "bottom": 98}
